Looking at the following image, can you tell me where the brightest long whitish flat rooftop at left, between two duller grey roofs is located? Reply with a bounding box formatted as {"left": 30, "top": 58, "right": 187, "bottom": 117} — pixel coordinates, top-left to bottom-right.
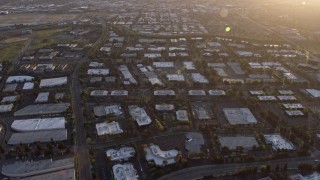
{"left": 11, "top": 117, "right": 66, "bottom": 132}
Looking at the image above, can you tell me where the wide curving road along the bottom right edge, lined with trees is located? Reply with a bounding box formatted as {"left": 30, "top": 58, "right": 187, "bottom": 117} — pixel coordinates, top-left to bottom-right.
{"left": 158, "top": 157, "right": 315, "bottom": 180}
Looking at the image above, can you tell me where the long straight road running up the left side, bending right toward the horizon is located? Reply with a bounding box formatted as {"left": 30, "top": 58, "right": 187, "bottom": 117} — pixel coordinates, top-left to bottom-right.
{"left": 71, "top": 20, "right": 106, "bottom": 180}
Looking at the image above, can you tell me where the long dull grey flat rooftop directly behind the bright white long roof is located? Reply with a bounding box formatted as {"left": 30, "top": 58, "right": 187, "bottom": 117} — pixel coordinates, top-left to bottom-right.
{"left": 14, "top": 103, "right": 70, "bottom": 116}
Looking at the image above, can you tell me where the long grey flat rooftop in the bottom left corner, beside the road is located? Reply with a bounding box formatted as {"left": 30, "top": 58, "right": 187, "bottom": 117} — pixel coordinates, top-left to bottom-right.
{"left": 1, "top": 158, "right": 74, "bottom": 177}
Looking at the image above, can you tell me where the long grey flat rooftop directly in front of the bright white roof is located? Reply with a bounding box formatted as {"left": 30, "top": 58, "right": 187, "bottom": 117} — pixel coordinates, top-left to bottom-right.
{"left": 8, "top": 129, "right": 67, "bottom": 145}
